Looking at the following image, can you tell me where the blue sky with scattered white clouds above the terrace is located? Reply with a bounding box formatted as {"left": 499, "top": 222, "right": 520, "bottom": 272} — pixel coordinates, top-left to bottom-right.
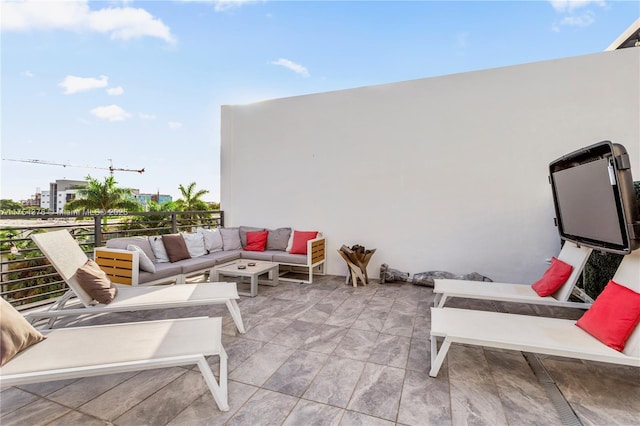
{"left": 0, "top": 0, "right": 640, "bottom": 201}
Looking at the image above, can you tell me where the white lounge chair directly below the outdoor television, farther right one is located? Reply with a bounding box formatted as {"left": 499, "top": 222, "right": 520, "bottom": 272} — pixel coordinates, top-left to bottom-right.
{"left": 433, "top": 241, "right": 593, "bottom": 309}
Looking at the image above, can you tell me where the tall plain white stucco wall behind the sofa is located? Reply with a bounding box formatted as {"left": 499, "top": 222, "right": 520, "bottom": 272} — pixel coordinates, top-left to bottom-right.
{"left": 221, "top": 48, "right": 640, "bottom": 283}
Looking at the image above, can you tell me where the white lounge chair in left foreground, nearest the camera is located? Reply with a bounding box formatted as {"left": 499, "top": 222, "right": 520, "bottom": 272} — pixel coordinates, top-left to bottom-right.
{"left": 0, "top": 317, "right": 229, "bottom": 411}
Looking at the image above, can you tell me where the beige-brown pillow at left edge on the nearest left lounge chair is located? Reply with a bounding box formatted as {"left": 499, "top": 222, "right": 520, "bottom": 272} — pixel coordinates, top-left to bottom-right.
{"left": 0, "top": 298, "right": 45, "bottom": 366}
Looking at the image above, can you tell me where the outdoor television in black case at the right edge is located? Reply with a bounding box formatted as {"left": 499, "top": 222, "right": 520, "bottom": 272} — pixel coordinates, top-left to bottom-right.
{"left": 549, "top": 141, "right": 640, "bottom": 254}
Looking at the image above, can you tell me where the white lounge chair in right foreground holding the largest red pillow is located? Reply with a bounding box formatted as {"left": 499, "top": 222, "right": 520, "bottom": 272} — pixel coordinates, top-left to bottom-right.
{"left": 429, "top": 250, "right": 640, "bottom": 377}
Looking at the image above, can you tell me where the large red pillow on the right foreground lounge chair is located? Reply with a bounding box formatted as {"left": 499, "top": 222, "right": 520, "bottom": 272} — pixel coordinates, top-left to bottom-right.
{"left": 576, "top": 280, "right": 640, "bottom": 351}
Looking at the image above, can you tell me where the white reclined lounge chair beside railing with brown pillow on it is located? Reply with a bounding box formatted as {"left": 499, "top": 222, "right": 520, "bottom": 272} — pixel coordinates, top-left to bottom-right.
{"left": 26, "top": 230, "right": 245, "bottom": 333}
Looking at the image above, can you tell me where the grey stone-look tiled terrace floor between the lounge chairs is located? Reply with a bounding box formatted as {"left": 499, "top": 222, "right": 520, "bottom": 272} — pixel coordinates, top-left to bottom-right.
{"left": 0, "top": 275, "right": 640, "bottom": 426}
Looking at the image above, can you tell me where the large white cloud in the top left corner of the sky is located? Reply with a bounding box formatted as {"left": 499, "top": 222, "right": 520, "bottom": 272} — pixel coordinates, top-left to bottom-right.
{"left": 1, "top": 0, "right": 175, "bottom": 43}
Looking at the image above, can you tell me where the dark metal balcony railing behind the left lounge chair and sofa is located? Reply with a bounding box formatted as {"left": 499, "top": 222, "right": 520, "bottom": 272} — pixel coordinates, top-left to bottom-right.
{"left": 0, "top": 210, "right": 224, "bottom": 310}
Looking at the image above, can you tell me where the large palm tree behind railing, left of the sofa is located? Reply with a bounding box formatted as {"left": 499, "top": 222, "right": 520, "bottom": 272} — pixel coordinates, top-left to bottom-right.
{"left": 65, "top": 176, "right": 140, "bottom": 224}
